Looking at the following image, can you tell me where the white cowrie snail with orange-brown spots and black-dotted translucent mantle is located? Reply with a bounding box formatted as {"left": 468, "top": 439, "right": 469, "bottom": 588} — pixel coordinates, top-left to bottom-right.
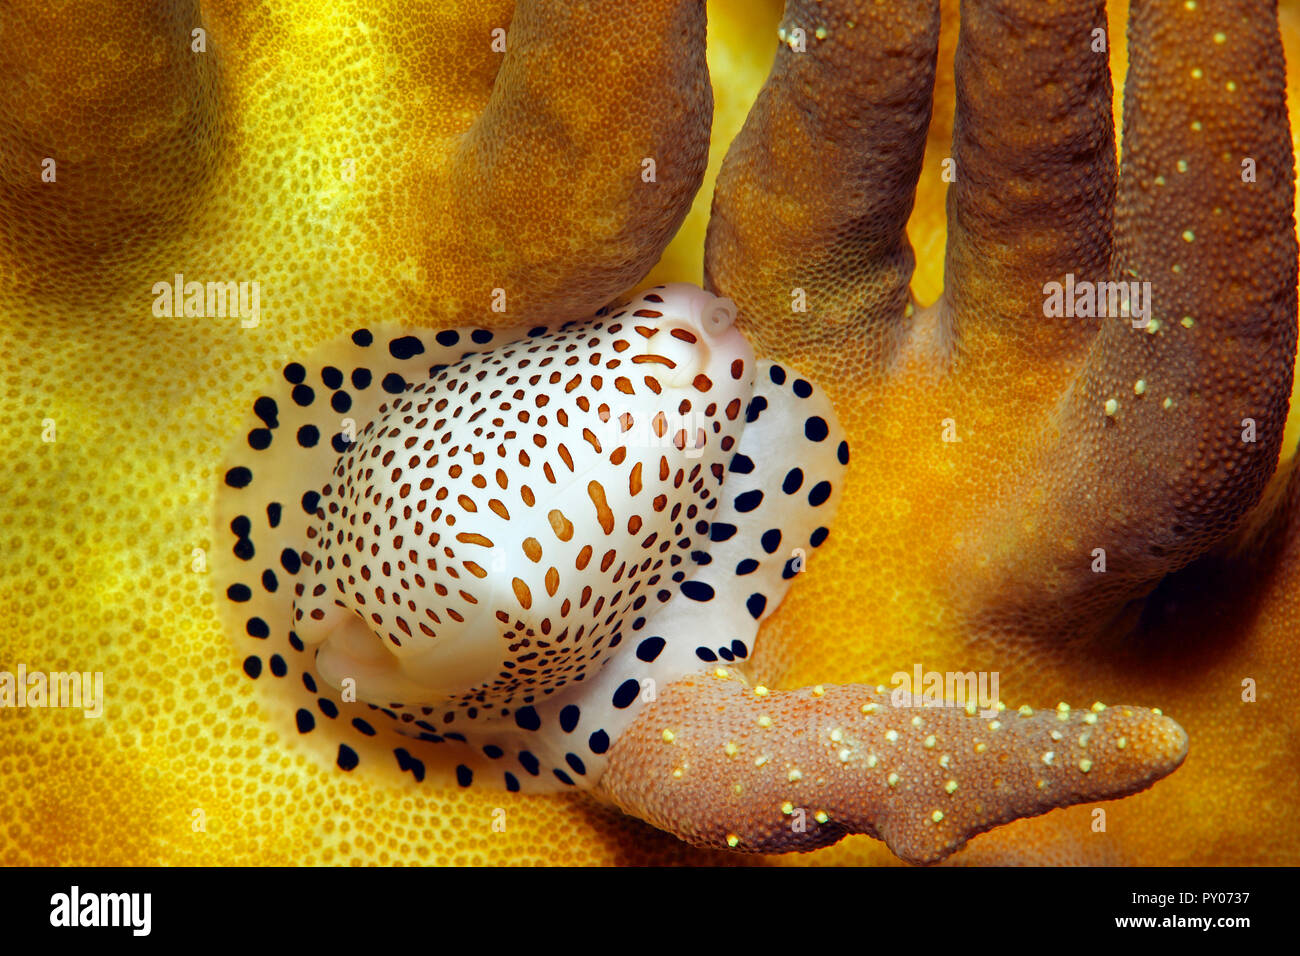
{"left": 216, "top": 285, "right": 848, "bottom": 791}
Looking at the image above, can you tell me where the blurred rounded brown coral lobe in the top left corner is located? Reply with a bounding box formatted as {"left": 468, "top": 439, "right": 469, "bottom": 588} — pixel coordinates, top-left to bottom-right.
{"left": 0, "top": 0, "right": 220, "bottom": 295}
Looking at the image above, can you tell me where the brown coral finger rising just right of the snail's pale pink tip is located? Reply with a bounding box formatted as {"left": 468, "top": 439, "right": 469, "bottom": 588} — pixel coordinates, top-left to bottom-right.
{"left": 705, "top": 0, "right": 939, "bottom": 381}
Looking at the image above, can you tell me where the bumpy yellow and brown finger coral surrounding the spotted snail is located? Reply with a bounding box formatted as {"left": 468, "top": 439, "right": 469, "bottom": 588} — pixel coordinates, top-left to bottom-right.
{"left": 0, "top": 0, "right": 1300, "bottom": 865}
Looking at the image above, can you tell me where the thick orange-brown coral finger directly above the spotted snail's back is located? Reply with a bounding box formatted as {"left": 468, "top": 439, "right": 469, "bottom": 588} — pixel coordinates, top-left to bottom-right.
{"left": 444, "top": 0, "right": 712, "bottom": 321}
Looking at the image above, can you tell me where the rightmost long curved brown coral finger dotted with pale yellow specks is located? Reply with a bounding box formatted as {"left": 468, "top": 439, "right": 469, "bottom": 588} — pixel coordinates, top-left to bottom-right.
{"left": 958, "top": 0, "right": 1296, "bottom": 642}
